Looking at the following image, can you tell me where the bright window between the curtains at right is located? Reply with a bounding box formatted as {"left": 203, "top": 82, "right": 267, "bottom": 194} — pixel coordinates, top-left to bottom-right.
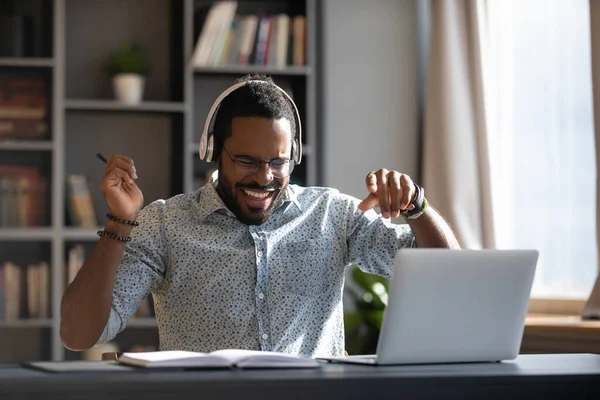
{"left": 482, "top": 0, "right": 598, "bottom": 299}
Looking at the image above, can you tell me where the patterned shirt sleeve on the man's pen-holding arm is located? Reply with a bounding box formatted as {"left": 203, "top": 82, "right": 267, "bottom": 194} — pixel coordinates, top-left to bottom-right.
{"left": 96, "top": 201, "right": 166, "bottom": 346}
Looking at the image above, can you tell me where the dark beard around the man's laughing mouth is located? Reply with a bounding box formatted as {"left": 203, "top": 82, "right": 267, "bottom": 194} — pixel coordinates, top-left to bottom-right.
{"left": 217, "top": 166, "right": 283, "bottom": 225}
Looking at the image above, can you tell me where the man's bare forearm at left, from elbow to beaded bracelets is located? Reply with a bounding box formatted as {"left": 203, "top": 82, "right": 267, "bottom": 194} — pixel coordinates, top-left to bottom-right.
{"left": 60, "top": 222, "right": 131, "bottom": 350}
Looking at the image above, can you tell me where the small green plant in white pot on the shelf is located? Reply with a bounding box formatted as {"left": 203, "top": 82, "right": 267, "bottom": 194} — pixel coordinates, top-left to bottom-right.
{"left": 107, "top": 44, "right": 148, "bottom": 104}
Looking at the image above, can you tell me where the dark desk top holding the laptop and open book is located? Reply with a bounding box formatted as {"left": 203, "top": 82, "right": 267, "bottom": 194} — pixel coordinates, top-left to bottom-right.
{"left": 0, "top": 354, "right": 600, "bottom": 400}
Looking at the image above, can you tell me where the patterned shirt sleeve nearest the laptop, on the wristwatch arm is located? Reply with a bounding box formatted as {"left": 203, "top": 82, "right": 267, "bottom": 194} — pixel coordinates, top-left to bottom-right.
{"left": 346, "top": 194, "right": 416, "bottom": 278}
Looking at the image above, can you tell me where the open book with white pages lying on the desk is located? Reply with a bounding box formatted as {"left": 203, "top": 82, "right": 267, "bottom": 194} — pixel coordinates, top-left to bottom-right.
{"left": 118, "top": 349, "right": 321, "bottom": 368}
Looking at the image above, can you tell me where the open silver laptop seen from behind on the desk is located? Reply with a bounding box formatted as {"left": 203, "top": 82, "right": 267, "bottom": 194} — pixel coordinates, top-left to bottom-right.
{"left": 320, "top": 249, "right": 538, "bottom": 365}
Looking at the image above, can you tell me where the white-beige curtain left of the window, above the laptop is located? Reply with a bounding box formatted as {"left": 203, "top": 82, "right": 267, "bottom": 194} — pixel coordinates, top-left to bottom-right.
{"left": 423, "top": 0, "right": 494, "bottom": 249}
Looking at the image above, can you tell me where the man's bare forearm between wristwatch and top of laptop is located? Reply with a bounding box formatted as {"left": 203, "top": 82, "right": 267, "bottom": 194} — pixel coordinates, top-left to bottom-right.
{"left": 408, "top": 207, "right": 460, "bottom": 249}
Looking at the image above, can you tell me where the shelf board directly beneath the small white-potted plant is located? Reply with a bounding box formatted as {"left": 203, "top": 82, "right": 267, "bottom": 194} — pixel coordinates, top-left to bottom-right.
{"left": 65, "top": 99, "right": 186, "bottom": 113}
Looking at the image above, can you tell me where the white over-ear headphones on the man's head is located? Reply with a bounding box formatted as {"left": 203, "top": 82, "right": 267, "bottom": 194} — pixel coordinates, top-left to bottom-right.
{"left": 199, "top": 80, "right": 302, "bottom": 164}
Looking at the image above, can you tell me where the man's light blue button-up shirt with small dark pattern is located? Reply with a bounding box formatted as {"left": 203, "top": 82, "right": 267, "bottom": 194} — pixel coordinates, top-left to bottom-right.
{"left": 97, "top": 172, "right": 414, "bottom": 357}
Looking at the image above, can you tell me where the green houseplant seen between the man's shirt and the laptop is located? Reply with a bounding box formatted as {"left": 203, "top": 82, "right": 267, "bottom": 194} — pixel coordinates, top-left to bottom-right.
{"left": 344, "top": 265, "right": 389, "bottom": 354}
